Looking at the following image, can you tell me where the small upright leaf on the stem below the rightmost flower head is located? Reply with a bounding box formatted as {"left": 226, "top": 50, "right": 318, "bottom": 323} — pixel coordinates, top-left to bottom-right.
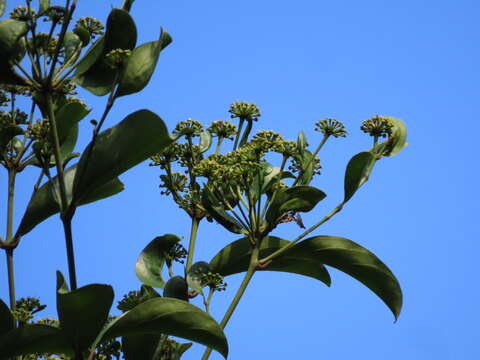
{"left": 343, "top": 151, "right": 375, "bottom": 202}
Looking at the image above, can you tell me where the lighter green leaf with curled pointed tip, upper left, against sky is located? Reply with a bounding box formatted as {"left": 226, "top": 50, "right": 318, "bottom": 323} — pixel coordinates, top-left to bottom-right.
{"left": 116, "top": 29, "right": 172, "bottom": 97}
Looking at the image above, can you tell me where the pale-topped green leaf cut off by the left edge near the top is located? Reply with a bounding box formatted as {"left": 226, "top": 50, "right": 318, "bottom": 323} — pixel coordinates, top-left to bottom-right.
{"left": 0, "top": 19, "right": 28, "bottom": 60}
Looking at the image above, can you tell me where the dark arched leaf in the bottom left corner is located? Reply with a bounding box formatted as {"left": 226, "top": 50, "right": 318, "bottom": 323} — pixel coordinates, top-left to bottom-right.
{"left": 0, "top": 324, "right": 72, "bottom": 360}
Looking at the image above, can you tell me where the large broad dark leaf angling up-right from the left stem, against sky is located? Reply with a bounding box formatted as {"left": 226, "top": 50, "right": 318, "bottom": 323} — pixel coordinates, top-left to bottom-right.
{"left": 74, "top": 110, "right": 172, "bottom": 202}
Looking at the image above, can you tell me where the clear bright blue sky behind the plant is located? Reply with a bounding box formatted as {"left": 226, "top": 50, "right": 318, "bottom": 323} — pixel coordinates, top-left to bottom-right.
{"left": 0, "top": 0, "right": 480, "bottom": 360}
